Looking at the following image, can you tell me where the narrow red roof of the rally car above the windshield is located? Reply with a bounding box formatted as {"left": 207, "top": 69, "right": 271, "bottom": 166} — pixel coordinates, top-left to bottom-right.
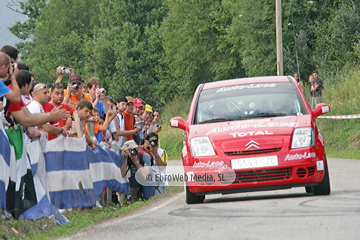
{"left": 203, "top": 76, "right": 291, "bottom": 90}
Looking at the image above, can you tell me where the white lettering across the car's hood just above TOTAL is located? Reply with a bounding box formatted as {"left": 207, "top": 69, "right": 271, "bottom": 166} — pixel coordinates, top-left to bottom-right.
{"left": 206, "top": 122, "right": 299, "bottom": 135}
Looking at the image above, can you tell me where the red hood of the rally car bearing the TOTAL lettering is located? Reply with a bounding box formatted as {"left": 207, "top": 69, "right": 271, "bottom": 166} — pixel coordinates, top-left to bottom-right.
{"left": 189, "top": 115, "right": 311, "bottom": 142}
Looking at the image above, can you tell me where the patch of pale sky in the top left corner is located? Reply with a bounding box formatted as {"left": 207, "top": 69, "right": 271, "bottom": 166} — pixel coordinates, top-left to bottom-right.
{"left": 0, "top": 0, "right": 27, "bottom": 48}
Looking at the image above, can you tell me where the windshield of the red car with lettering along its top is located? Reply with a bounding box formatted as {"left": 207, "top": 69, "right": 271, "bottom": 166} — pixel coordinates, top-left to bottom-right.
{"left": 194, "top": 82, "right": 307, "bottom": 124}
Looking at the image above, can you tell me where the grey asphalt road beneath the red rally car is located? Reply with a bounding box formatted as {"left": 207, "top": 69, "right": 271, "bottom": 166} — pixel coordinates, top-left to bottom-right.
{"left": 59, "top": 159, "right": 360, "bottom": 240}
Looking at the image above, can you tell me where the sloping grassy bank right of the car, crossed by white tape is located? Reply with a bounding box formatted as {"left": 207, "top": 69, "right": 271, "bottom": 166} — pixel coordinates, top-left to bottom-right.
{"left": 317, "top": 70, "right": 360, "bottom": 159}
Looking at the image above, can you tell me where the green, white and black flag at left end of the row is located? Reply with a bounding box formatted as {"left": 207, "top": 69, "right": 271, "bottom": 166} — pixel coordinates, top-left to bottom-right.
{"left": 5, "top": 127, "right": 37, "bottom": 219}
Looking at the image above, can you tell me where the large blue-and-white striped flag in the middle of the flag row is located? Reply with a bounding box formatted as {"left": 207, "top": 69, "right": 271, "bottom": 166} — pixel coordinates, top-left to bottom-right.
{"left": 45, "top": 136, "right": 96, "bottom": 209}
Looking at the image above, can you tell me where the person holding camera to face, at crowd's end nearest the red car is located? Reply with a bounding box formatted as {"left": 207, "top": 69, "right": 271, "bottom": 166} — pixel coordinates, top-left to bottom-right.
{"left": 144, "top": 132, "right": 168, "bottom": 194}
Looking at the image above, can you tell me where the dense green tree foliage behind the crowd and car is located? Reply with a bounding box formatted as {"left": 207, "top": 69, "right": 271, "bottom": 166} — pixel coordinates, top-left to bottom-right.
{"left": 7, "top": 0, "right": 360, "bottom": 105}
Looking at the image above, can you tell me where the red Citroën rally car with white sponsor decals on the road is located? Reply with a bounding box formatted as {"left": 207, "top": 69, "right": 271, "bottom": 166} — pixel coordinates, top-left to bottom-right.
{"left": 170, "top": 76, "right": 330, "bottom": 204}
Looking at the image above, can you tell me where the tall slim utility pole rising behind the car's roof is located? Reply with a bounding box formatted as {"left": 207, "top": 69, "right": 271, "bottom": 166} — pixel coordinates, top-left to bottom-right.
{"left": 275, "top": 0, "right": 284, "bottom": 76}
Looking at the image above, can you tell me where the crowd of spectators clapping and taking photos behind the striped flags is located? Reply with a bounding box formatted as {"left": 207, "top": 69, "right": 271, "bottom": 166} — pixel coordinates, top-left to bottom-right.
{"left": 0, "top": 45, "right": 168, "bottom": 206}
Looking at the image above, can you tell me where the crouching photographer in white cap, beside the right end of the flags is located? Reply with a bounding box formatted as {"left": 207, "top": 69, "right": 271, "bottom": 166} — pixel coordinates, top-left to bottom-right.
{"left": 123, "top": 140, "right": 155, "bottom": 201}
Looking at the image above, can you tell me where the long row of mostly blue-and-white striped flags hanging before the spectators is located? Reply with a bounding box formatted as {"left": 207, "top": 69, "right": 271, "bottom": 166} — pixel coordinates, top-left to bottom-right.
{"left": 0, "top": 119, "right": 129, "bottom": 224}
